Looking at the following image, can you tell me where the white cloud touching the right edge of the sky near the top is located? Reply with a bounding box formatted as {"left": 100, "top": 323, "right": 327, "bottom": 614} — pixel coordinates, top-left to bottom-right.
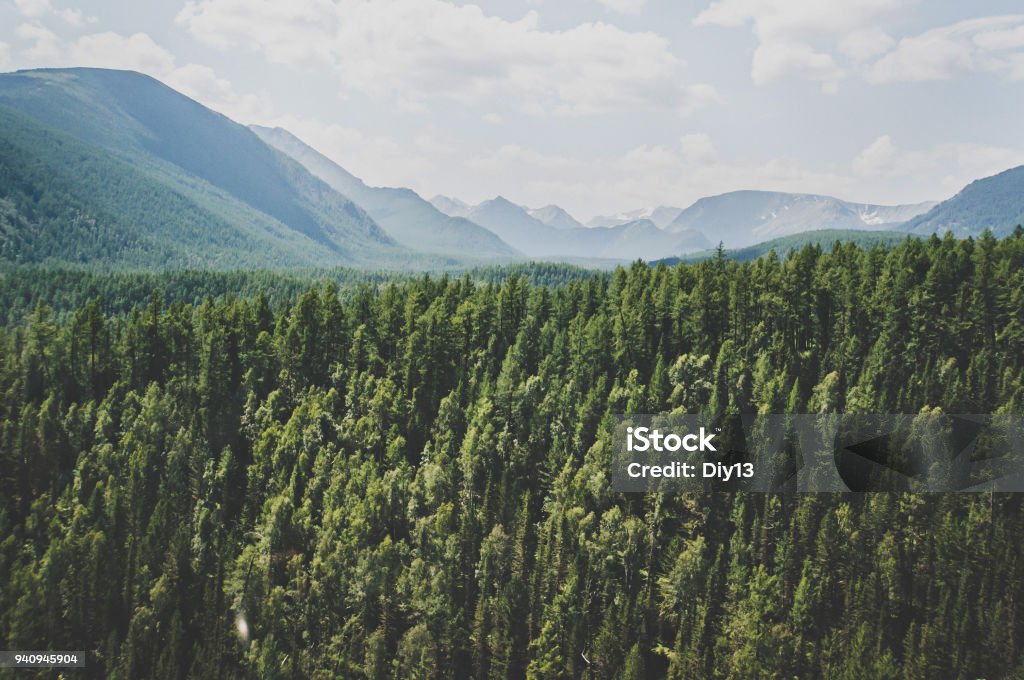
{"left": 867, "top": 14, "right": 1024, "bottom": 83}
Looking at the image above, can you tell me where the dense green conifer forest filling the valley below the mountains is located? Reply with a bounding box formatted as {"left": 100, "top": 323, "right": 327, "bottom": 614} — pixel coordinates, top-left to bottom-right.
{"left": 0, "top": 227, "right": 1024, "bottom": 679}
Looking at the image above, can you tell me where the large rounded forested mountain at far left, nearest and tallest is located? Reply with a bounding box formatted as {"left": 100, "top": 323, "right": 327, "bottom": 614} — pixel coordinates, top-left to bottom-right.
{"left": 0, "top": 69, "right": 410, "bottom": 268}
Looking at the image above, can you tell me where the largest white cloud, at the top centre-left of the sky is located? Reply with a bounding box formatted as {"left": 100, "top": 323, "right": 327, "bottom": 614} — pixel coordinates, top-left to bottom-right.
{"left": 177, "top": 0, "right": 716, "bottom": 115}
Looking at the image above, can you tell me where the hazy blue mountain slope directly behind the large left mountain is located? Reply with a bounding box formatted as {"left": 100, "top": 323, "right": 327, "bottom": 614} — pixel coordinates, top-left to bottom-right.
{"left": 250, "top": 125, "right": 519, "bottom": 259}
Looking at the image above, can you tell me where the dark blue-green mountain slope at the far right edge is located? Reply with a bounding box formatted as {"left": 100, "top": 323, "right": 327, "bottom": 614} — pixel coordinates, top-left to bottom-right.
{"left": 901, "top": 166, "right": 1024, "bottom": 238}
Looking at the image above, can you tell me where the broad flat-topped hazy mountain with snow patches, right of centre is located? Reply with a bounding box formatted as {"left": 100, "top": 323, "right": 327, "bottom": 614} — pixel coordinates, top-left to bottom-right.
{"left": 667, "top": 190, "right": 935, "bottom": 248}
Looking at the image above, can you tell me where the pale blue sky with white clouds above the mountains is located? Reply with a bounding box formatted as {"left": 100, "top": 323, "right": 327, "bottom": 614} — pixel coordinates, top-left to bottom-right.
{"left": 0, "top": 0, "right": 1024, "bottom": 219}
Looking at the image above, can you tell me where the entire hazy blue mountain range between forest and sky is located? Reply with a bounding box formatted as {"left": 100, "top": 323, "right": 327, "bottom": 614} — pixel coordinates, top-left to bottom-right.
{"left": 0, "top": 69, "right": 1024, "bottom": 268}
